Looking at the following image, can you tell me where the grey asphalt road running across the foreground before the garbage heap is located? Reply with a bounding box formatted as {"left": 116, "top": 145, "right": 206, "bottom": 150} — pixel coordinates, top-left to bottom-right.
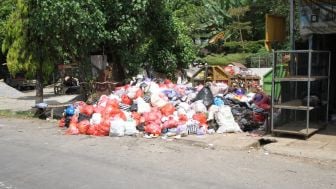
{"left": 0, "top": 118, "right": 336, "bottom": 189}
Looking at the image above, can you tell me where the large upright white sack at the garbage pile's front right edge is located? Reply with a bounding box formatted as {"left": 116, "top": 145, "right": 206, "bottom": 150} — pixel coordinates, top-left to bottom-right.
{"left": 215, "top": 106, "right": 242, "bottom": 133}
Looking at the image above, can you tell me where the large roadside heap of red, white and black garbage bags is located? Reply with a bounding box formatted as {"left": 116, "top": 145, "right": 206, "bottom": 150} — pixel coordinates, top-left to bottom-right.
{"left": 59, "top": 79, "right": 270, "bottom": 136}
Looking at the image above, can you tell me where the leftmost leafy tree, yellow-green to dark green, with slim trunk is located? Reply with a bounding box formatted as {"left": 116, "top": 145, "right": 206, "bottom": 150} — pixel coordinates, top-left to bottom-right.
{"left": 2, "top": 0, "right": 105, "bottom": 102}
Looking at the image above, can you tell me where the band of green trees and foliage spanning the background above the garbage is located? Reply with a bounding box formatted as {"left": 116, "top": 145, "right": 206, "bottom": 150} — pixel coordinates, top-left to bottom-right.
{"left": 0, "top": 0, "right": 288, "bottom": 102}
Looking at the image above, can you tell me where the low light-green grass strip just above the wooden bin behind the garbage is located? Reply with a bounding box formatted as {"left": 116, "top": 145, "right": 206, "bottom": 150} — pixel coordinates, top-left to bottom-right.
{"left": 203, "top": 53, "right": 251, "bottom": 65}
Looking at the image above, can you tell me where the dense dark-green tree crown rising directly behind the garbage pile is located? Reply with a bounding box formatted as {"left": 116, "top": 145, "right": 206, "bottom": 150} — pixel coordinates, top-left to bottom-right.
{"left": 94, "top": 0, "right": 195, "bottom": 76}
